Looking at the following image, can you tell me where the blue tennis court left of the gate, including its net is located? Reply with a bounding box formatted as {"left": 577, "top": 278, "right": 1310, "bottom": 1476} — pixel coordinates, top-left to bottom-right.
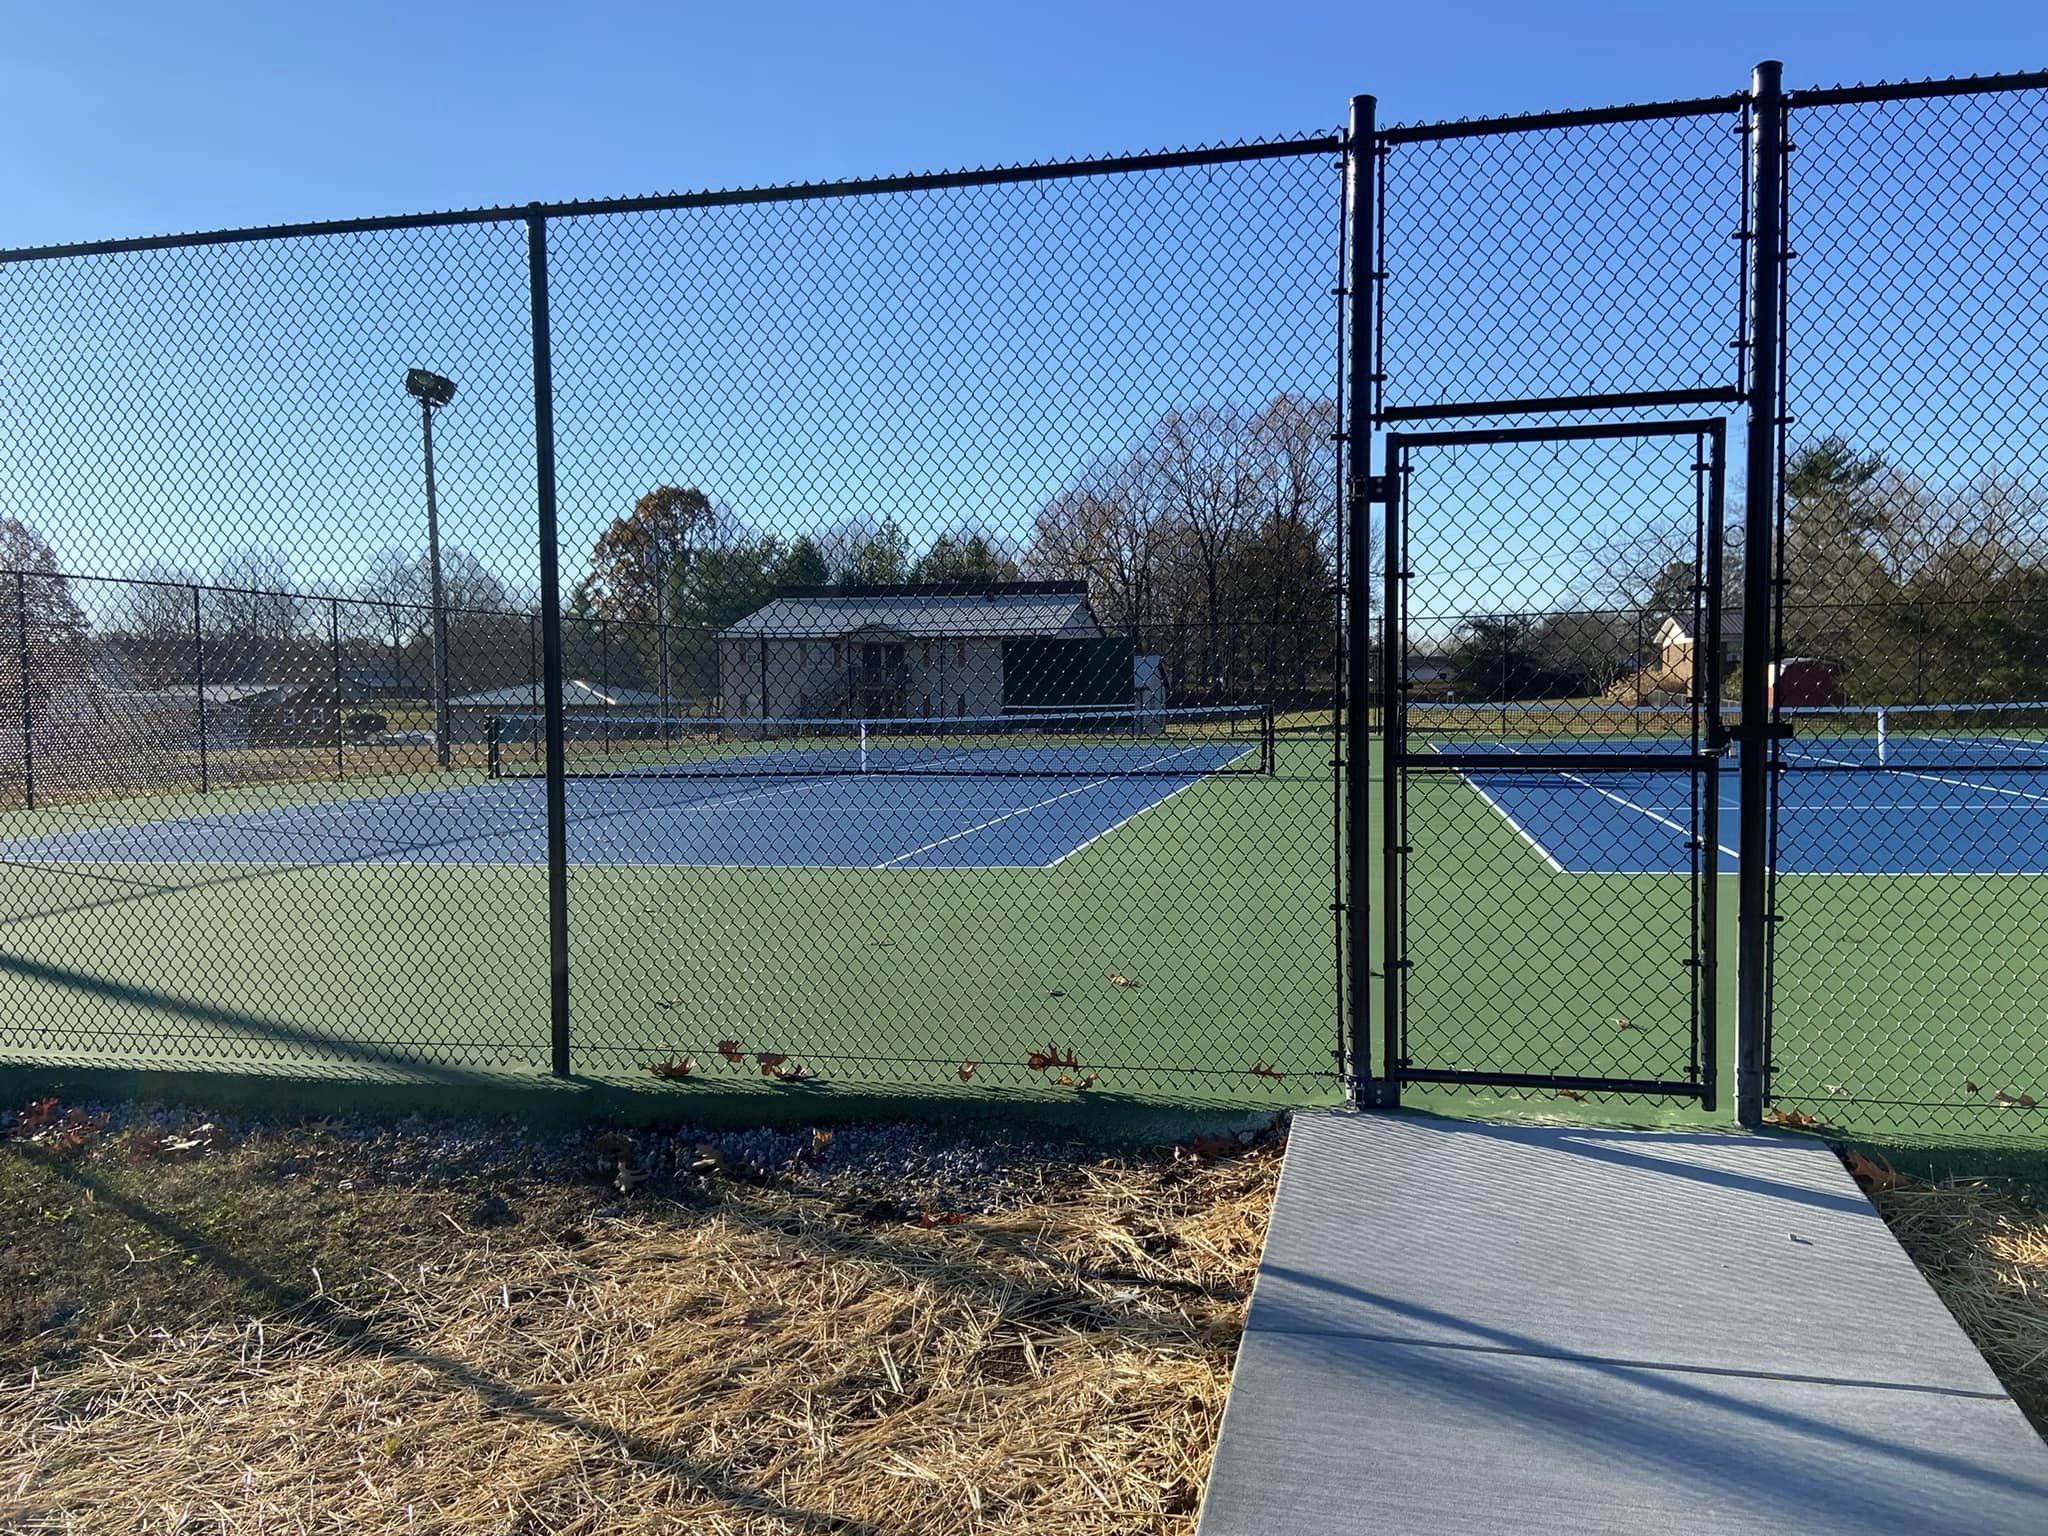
{"left": 0, "top": 711, "right": 1270, "bottom": 870}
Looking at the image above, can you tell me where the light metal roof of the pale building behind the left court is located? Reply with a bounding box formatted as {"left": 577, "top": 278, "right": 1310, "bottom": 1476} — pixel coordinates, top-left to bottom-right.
{"left": 719, "top": 582, "right": 1102, "bottom": 639}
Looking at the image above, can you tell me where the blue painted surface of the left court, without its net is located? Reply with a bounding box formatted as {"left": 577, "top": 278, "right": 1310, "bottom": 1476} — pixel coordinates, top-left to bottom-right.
{"left": 0, "top": 743, "right": 1241, "bottom": 870}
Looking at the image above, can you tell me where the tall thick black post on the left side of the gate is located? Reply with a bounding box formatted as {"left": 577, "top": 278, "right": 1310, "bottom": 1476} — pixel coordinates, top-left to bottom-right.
{"left": 1339, "top": 96, "right": 1401, "bottom": 1108}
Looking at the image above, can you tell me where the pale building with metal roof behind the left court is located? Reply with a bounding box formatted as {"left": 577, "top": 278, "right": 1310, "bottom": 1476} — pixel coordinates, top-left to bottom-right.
{"left": 719, "top": 582, "right": 1102, "bottom": 719}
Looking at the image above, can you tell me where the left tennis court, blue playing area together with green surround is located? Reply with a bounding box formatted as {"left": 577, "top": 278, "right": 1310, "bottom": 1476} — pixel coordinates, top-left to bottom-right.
{"left": 0, "top": 711, "right": 1335, "bottom": 1102}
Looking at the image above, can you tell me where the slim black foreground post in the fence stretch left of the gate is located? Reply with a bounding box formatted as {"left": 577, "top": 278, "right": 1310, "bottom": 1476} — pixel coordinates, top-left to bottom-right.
{"left": 526, "top": 203, "right": 569, "bottom": 1077}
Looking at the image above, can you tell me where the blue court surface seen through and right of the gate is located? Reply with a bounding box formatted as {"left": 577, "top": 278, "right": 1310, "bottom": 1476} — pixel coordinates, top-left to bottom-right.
{"left": 1460, "top": 739, "right": 2048, "bottom": 874}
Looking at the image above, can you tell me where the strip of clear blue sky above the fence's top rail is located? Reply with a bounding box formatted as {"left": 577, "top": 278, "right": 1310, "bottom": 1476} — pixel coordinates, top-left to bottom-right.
{"left": 12, "top": 0, "right": 2048, "bottom": 246}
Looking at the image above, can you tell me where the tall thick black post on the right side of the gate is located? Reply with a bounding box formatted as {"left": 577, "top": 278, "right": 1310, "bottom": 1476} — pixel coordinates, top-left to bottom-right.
{"left": 1735, "top": 59, "right": 1786, "bottom": 1126}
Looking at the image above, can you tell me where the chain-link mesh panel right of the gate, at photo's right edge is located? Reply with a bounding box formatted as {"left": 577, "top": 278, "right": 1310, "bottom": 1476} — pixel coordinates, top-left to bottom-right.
{"left": 1772, "top": 88, "right": 2048, "bottom": 1135}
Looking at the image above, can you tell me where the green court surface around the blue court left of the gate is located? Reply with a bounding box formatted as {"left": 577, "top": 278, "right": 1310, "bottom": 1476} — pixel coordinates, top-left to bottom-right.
{"left": 0, "top": 741, "right": 1337, "bottom": 1106}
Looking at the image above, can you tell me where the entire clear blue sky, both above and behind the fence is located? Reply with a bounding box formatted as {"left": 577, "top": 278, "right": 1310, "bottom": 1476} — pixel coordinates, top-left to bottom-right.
{"left": 0, "top": 0, "right": 2048, "bottom": 626}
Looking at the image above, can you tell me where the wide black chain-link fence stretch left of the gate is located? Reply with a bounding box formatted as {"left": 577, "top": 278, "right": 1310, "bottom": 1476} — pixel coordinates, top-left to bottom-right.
{"left": 0, "top": 135, "right": 1343, "bottom": 1100}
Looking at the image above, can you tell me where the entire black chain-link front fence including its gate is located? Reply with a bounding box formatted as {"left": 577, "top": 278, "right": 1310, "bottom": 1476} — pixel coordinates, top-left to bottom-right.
{"left": 0, "top": 70, "right": 2048, "bottom": 1135}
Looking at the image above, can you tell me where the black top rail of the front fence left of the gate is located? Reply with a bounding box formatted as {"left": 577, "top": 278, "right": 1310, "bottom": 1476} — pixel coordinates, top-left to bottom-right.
{"left": 0, "top": 131, "right": 1343, "bottom": 264}
